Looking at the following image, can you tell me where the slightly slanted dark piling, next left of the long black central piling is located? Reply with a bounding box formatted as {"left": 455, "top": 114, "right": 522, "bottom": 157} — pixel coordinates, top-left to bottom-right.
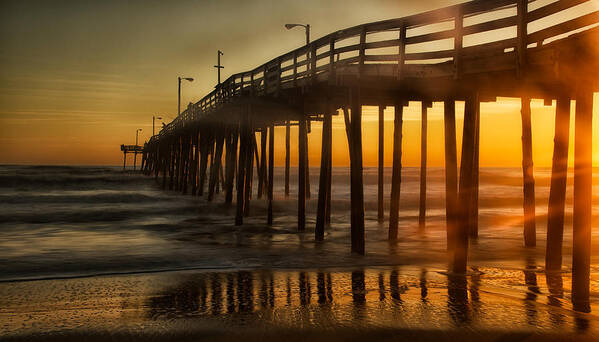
{"left": 314, "top": 113, "right": 333, "bottom": 241}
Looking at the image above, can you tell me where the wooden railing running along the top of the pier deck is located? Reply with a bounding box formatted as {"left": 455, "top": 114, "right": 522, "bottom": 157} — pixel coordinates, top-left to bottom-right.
{"left": 153, "top": 0, "right": 599, "bottom": 139}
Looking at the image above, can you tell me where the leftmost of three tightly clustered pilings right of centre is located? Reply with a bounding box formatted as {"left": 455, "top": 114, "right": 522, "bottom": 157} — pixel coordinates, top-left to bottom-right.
{"left": 444, "top": 99, "right": 458, "bottom": 250}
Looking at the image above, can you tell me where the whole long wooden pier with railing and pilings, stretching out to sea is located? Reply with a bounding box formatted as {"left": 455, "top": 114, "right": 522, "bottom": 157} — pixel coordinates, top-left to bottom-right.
{"left": 142, "top": 0, "right": 599, "bottom": 303}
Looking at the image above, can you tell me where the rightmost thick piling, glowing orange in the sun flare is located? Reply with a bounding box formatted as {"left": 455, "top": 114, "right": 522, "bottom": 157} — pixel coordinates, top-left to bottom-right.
{"left": 572, "top": 86, "right": 593, "bottom": 312}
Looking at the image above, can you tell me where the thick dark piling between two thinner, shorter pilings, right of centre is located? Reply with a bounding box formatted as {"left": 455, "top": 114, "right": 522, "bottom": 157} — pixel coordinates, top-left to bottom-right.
{"left": 389, "top": 99, "right": 404, "bottom": 241}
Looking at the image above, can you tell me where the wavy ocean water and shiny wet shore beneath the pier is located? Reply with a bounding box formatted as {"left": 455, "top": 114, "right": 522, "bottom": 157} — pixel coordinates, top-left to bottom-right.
{"left": 0, "top": 166, "right": 599, "bottom": 339}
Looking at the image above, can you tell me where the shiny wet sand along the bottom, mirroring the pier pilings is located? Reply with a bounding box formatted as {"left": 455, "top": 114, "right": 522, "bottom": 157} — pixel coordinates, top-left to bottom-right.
{"left": 0, "top": 266, "right": 599, "bottom": 341}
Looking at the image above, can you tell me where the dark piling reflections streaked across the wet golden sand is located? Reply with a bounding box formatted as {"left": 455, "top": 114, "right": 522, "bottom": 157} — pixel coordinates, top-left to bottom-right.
{"left": 147, "top": 262, "right": 592, "bottom": 333}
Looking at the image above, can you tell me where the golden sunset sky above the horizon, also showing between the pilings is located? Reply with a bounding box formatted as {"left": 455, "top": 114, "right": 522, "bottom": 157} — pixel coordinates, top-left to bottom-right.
{"left": 0, "top": 0, "right": 599, "bottom": 166}
